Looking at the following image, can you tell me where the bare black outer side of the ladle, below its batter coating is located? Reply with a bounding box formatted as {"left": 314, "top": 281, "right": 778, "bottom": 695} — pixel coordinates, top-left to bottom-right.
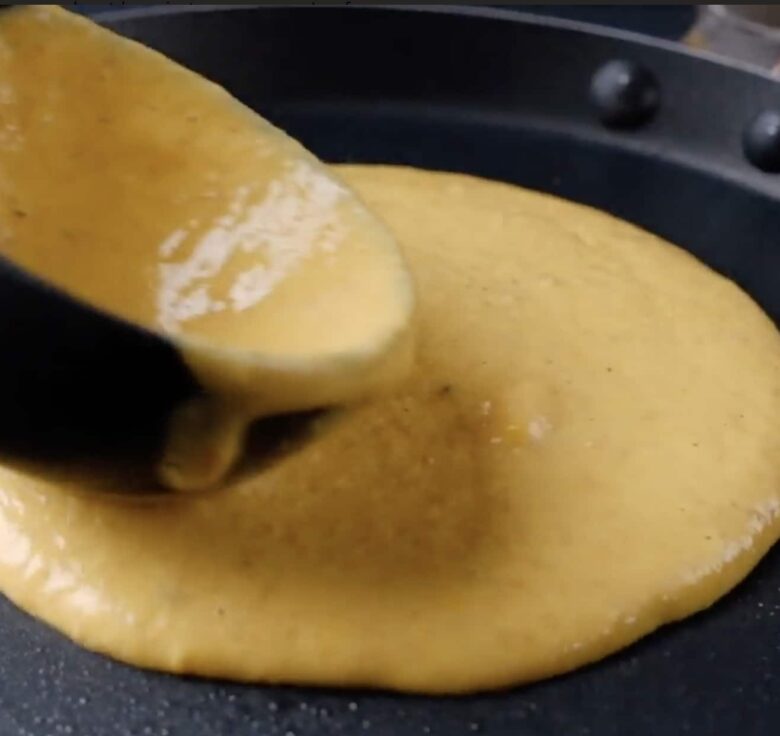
{"left": 0, "top": 256, "right": 201, "bottom": 490}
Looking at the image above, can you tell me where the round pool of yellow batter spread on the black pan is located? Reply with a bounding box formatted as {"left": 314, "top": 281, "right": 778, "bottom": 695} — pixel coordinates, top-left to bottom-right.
{"left": 0, "top": 167, "right": 780, "bottom": 692}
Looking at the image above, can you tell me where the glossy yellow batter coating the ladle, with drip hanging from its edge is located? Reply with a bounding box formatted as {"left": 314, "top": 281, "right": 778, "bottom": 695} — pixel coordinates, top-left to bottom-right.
{"left": 0, "top": 6, "right": 413, "bottom": 487}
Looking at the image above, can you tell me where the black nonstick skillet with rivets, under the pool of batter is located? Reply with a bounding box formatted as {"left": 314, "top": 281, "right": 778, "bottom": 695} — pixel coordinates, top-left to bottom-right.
{"left": 0, "top": 8, "right": 780, "bottom": 736}
